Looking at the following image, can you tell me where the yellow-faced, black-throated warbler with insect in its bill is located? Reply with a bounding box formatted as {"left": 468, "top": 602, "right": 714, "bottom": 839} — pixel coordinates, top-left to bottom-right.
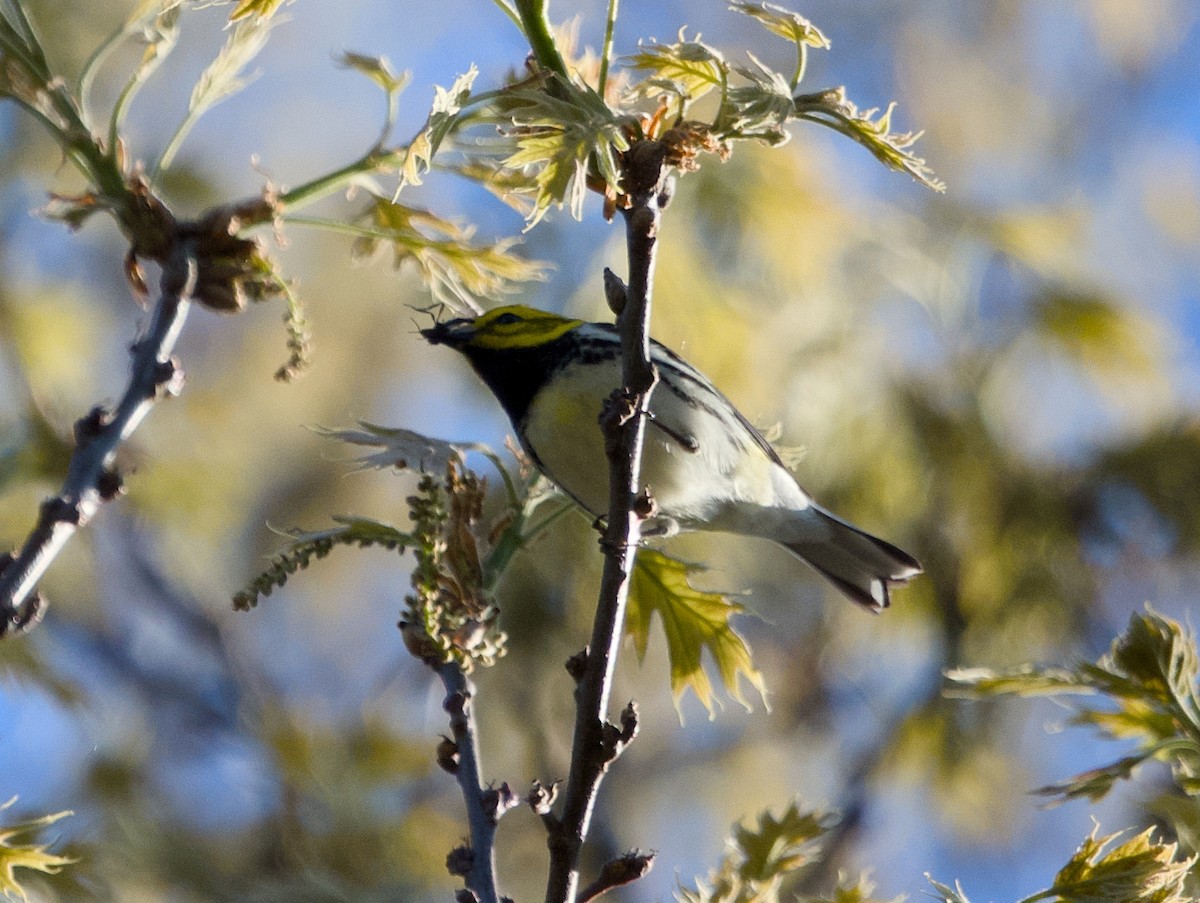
{"left": 420, "top": 304, "right": 922, "bottom": 611}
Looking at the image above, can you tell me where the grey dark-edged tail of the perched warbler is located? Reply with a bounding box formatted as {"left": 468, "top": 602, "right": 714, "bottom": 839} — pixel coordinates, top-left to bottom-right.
{"left": 784, "top": 506, "right": 922, "bottom": 611}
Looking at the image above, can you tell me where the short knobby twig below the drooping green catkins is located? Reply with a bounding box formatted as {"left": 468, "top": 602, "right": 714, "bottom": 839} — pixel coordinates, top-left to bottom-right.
{"left": 437, "top": 662, "right": 518, "bottom": 903}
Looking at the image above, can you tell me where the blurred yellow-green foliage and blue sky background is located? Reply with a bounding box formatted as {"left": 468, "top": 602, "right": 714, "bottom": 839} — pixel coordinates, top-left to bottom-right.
{"left": 0, "top": 0, "right": 1200, "bottom": 901}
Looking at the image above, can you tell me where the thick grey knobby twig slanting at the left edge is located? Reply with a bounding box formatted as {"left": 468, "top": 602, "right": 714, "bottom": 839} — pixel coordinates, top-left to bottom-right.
{"left": 0, "top": 239, "right": 198, "bottom": 635}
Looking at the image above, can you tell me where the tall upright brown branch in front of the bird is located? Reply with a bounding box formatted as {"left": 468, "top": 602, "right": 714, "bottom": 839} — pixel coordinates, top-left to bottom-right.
{"left": 546, "top": 142, "right": 667, "bottom": 903}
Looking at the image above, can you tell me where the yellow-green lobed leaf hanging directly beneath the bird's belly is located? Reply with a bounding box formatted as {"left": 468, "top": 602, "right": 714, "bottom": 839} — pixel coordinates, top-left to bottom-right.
{"left": 625, "top": 549, "right": 767, "bottom": 713}
